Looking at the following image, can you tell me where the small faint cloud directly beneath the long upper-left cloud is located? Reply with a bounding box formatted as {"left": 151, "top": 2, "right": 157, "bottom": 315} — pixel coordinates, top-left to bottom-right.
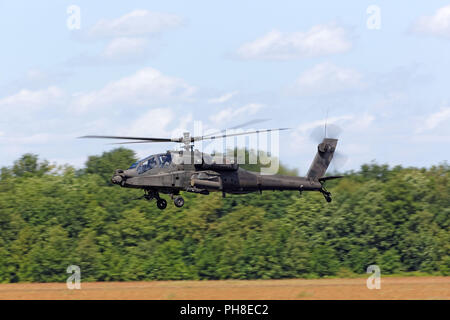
{"left": 102, "top": 37, "right": 148, "bottom": 60}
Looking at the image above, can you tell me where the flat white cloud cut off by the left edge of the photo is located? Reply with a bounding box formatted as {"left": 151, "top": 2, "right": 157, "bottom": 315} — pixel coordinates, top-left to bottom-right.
{"left": 0, "top": 86, "right": 65, "bottom": 112}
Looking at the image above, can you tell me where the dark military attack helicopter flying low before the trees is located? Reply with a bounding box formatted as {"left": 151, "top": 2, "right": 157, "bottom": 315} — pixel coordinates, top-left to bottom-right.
{"left": 79, "top": 123, "right": 342, "bottom": 210}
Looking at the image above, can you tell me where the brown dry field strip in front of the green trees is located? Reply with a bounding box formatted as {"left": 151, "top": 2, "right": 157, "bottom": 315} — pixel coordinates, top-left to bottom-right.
{"left": 0, "top": 277, "right": 450, "bottom": 300}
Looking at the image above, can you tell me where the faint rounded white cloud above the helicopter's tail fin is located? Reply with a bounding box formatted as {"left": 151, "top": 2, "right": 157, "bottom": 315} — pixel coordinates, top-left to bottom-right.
{"left": 293, "top": 63, "right": 364, "bottom": 95}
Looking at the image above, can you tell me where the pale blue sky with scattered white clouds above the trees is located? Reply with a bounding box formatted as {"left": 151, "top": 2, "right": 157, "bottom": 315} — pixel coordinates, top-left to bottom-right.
{"left": 0, "top": 0, "right": 450, "bottom": 174}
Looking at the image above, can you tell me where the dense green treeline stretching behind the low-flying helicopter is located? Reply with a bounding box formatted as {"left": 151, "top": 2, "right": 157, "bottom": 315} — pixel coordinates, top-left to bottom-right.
{"left": 0, "top": 148, "right": 450, "bottom": 282}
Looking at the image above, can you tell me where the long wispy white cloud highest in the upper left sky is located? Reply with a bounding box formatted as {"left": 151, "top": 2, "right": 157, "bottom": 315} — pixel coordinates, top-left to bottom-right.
{"left": 88, "top": 10, "right": 182, "bottom": 38}
